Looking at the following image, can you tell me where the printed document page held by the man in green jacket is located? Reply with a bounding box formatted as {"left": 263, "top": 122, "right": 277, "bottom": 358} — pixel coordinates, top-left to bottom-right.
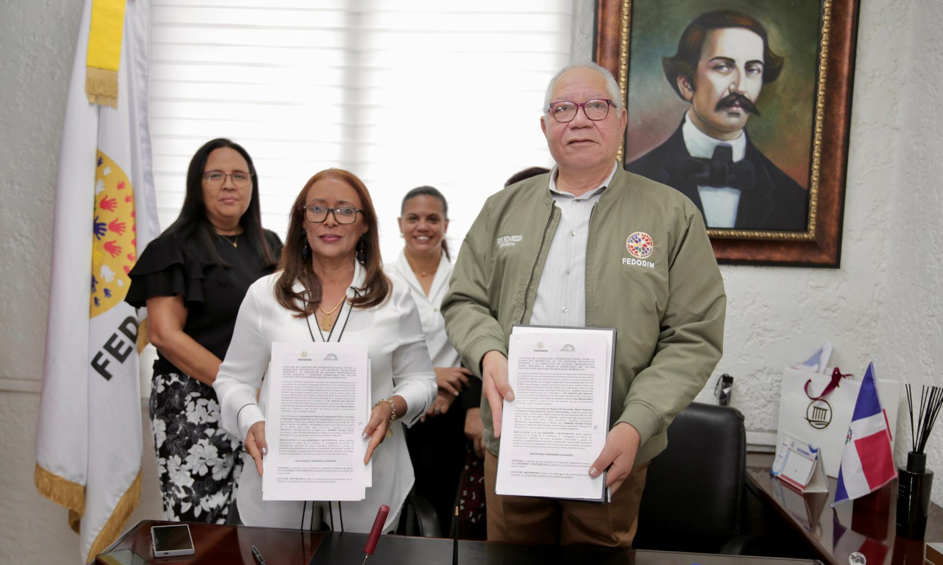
{"left": 495, "top": 326, "right": 615, "bottom": 501}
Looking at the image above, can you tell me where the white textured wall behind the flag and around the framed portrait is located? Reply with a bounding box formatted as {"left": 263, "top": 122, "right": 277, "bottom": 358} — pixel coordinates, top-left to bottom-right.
{"left": 0, "top": 0, "right": 943, "bottom": 563}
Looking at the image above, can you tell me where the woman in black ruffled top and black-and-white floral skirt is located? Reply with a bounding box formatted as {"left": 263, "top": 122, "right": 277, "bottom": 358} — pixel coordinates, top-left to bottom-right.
{"left": 125, "top": 139, "right": 282, "bottom": 523}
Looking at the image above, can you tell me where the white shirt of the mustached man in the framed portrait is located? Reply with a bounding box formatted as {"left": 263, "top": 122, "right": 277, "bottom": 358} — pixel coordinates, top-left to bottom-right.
{"left": 681, "top": 110, "right": 747, "bottom": 228}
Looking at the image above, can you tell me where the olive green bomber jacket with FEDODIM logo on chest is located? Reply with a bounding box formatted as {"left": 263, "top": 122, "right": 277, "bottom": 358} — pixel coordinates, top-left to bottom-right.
{"left": 442, "top": 167, "right": 727, "bottom": 464}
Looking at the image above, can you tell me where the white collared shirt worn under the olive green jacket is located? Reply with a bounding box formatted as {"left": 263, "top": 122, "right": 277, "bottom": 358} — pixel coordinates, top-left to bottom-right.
{"left": 530, "top": 159, "right": 619, "bottom": 327}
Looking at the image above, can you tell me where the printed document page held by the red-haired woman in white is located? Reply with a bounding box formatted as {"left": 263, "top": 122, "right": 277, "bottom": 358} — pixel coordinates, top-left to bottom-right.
{"left": 262, "top": 342, "right": 370, "bottom": 501}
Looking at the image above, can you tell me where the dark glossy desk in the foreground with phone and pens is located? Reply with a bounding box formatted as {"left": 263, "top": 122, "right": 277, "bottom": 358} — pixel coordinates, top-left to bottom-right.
{"left": 93, "top": 520, "right": 815, "bottom": 565}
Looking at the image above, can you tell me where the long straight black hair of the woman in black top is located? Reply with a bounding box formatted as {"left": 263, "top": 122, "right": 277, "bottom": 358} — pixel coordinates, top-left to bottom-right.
{"left": 164, "top": 137, "right": 278, "bottom": 268}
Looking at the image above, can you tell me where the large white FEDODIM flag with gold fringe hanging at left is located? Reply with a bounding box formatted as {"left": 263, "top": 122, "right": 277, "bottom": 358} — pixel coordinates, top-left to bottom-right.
{"left": 36, "top": 0, "right": 159, "bottom": 562}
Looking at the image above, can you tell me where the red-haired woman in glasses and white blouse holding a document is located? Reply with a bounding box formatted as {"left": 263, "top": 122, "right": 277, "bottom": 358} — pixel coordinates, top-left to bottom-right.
{"left": 213, "top": 169, "right": 436, "bottom": 532}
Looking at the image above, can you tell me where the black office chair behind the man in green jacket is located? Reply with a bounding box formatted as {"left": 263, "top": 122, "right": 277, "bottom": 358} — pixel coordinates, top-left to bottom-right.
{"left": 633, "top": 403, "right": 750, "bottom": 554}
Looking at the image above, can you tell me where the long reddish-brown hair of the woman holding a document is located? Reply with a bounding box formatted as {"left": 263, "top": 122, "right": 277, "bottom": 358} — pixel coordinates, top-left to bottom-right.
{"left": 275, "top": 169, "right": 391, "bottom": 318}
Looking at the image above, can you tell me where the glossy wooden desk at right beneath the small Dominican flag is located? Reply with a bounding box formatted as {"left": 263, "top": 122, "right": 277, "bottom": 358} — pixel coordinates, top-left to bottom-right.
{"left": 747, "top": 453, "right": 943, "bottom": 565}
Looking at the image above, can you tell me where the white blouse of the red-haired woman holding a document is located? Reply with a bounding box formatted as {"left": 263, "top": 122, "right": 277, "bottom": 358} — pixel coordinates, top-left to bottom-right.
{"left": 213, "top": 263, "right": 436, "bottom": 533}
